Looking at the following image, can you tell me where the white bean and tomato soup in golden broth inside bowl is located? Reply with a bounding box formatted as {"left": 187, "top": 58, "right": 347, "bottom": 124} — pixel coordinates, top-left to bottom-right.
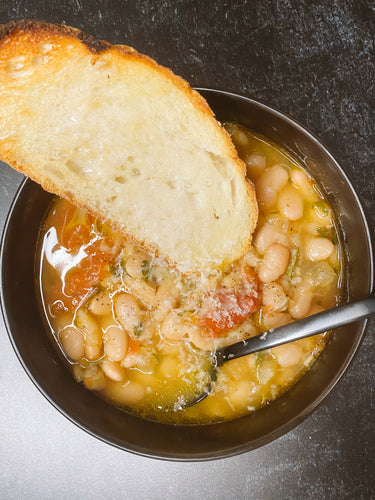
{"left": 38, "top": 123, "right": 341, "bottom": 424}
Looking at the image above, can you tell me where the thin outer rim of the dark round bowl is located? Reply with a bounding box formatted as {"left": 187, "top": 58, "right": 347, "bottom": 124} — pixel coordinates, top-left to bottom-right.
{"left": 0, "top": 87, "right": 374, "bottom": 462}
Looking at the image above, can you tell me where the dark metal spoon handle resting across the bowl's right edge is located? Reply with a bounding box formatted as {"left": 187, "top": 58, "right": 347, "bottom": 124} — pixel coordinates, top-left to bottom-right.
{"left": 216, "top": 294, "right": 375, "bottom": 366}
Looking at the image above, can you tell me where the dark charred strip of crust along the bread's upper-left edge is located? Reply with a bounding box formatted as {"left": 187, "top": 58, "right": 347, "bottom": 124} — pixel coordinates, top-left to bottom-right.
{"left": 0, "top": 19, "right": 111, "bottom": 54}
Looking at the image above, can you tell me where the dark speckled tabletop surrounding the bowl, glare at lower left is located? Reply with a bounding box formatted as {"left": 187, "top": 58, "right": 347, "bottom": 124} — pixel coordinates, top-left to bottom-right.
{"left": 0, "top": 0, "right": 375, "bottom": 500}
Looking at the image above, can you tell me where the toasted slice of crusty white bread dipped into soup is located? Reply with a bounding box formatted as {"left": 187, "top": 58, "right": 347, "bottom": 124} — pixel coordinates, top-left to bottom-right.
{"left": 0, "top": 21, "right": 258, "bottom": 271}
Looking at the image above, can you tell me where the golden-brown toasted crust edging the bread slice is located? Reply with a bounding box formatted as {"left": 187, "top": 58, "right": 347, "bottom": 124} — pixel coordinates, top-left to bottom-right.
{"left": 0, "top": 21, "right": 258, "bottom": 272}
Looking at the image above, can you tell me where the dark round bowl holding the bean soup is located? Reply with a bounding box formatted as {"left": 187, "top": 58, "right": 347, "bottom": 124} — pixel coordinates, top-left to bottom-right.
{"left": 1, "top": 89, "right": 373, "bottom": 460}
